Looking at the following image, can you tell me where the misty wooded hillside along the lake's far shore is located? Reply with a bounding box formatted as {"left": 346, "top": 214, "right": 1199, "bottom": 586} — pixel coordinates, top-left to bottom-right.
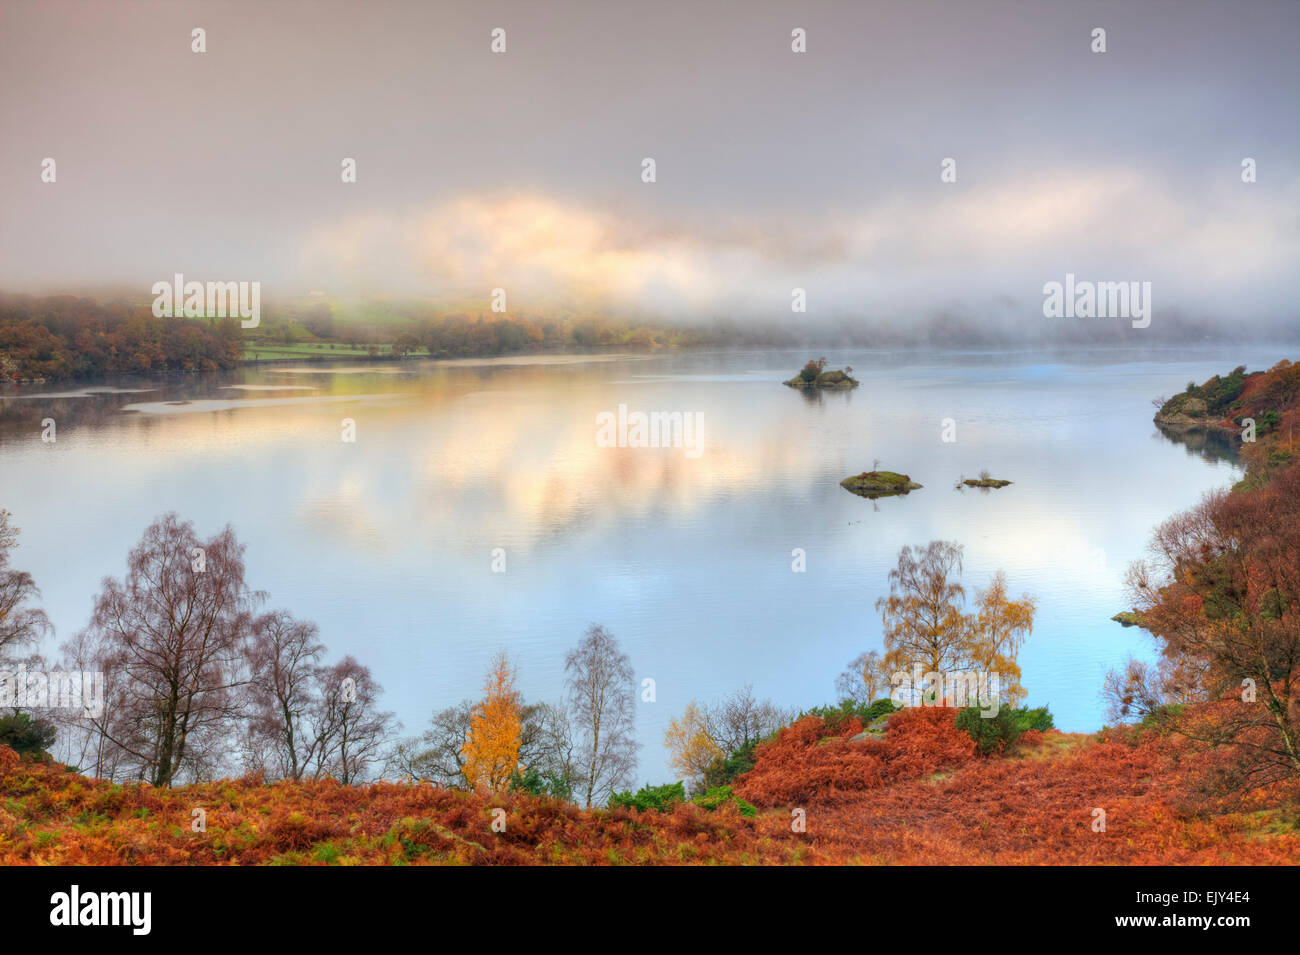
{"left": 10, "top": 288, "right": 1296, "bottom": 382}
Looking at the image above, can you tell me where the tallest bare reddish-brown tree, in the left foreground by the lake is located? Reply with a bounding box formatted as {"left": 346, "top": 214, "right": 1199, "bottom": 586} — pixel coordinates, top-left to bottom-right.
{"left": 79, "top": 513, "right": 260, "bottom": 786}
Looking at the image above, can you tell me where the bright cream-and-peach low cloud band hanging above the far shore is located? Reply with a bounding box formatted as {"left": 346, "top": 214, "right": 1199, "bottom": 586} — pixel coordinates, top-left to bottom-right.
{"left": 299, "top": 174, "right": 1300, "bottom": 330}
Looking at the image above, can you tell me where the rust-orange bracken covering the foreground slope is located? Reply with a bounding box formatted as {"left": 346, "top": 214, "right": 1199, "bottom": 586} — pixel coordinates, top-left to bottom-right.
{"left": 0, "top": 709, "right": 1300, "bottom": 865}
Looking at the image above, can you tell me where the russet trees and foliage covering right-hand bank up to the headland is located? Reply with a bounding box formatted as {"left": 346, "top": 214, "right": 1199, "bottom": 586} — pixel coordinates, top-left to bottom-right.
{"left": 1106, "top": 361, "right": 1300, "bottom": 799}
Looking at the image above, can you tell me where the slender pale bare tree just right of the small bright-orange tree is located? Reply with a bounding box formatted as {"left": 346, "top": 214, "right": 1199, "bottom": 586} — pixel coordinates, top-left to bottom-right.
{"left": 564, "top": 624, "right": 637, "bottom": 808}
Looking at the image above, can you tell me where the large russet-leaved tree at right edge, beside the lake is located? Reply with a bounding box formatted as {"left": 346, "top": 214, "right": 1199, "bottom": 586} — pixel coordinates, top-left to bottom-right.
{"left": 1112, "top": 456, "right": 1300, "bottom": 794}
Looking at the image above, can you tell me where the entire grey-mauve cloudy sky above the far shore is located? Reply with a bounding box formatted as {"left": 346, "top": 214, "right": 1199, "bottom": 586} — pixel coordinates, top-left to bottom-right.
{"left": 0, "top": 0, "right": 1300, "bottom": 324}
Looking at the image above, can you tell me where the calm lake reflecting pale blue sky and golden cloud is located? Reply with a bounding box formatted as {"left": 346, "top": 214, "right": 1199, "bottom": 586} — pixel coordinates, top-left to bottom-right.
{"left": 0, "top": 346, "right": 1287, "bottom": 782}
